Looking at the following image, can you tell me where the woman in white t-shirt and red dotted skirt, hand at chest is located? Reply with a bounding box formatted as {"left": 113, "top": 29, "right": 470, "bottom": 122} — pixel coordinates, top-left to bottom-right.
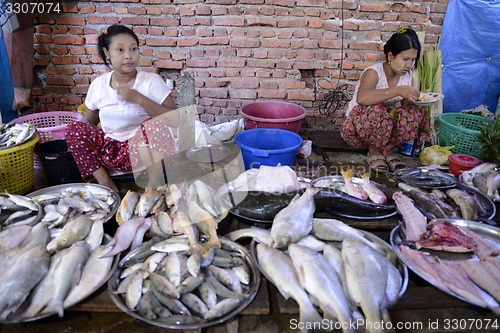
{"left": 66, "top": 25, "right": 180, "bottom": 190}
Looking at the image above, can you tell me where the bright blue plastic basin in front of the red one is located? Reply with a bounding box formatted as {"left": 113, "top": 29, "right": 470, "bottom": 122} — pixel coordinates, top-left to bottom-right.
{"left": 234, "top": 128, "right": 303, "bottom": 170}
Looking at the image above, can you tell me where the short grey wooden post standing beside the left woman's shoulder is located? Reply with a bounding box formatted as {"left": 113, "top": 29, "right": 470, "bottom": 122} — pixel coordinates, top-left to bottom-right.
{"left": 177, "top": 72, "right": 198, "bottom": 151}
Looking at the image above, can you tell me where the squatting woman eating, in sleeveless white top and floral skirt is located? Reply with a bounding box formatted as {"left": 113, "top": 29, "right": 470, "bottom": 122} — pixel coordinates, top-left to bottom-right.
{"left": 340, "top": 28, "right": 429, "bottom": 173}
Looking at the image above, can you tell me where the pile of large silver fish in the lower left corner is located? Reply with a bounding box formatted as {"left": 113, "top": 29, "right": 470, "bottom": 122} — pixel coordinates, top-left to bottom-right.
{"left": 0, "top": 211, "right": 114, "bottom": 322}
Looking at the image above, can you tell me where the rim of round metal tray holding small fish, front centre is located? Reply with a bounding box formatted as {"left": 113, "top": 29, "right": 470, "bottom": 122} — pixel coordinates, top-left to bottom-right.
{"left": 108, "top": 237, "right": 261, "bottom": 330}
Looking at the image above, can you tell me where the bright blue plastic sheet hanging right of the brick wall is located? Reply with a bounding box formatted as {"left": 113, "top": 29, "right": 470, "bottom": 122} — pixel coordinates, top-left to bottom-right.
{"left": 440, "top": 0, "right": 500, "bottom": 112}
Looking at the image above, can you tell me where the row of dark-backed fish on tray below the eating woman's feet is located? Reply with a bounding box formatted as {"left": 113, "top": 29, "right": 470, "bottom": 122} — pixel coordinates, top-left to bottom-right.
{"left": 398, "top": 182, "right": 491, "bottom": 220}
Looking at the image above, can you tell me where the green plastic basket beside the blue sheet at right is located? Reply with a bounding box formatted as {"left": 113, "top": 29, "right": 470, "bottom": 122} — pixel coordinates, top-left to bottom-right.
{"left": 438, "top": 113, "right": 493, "bottom": 160}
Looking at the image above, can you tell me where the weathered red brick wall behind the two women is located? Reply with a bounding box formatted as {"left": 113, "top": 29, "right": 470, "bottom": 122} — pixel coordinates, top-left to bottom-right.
{"left": 33, "top": 0, "right": 448, "bottom": 126}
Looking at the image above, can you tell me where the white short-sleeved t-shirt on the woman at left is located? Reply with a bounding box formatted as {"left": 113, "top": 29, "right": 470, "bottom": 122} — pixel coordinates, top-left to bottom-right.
{"left": 85, "top": 71, "right": 172, "bottom": 142}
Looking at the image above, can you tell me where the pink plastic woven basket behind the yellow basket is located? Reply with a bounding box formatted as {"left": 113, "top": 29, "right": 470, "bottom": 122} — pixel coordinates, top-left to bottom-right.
{"left": 10, "top": 111, "right": 83, "bottom": 169}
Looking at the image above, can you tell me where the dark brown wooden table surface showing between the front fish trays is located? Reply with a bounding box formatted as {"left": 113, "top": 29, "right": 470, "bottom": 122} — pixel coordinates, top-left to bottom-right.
{"left": 0, "top": 218, "right": 500, "bottom": 333}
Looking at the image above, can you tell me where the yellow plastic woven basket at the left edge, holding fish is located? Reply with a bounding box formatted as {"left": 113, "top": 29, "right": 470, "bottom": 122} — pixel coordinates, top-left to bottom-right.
{"left": 0, "top": 135, "right": 38, "bottom": 194}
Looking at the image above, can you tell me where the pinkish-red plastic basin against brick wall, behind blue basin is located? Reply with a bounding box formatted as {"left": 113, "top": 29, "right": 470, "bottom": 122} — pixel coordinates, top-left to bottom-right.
{"left": 239, "top": 101, "right": 306, "bottom": 133}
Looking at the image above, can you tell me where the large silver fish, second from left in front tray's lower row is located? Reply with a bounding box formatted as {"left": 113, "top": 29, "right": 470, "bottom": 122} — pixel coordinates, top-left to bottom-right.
{"left": 288, "top": 244, "right": 354, "bottom": 332}
